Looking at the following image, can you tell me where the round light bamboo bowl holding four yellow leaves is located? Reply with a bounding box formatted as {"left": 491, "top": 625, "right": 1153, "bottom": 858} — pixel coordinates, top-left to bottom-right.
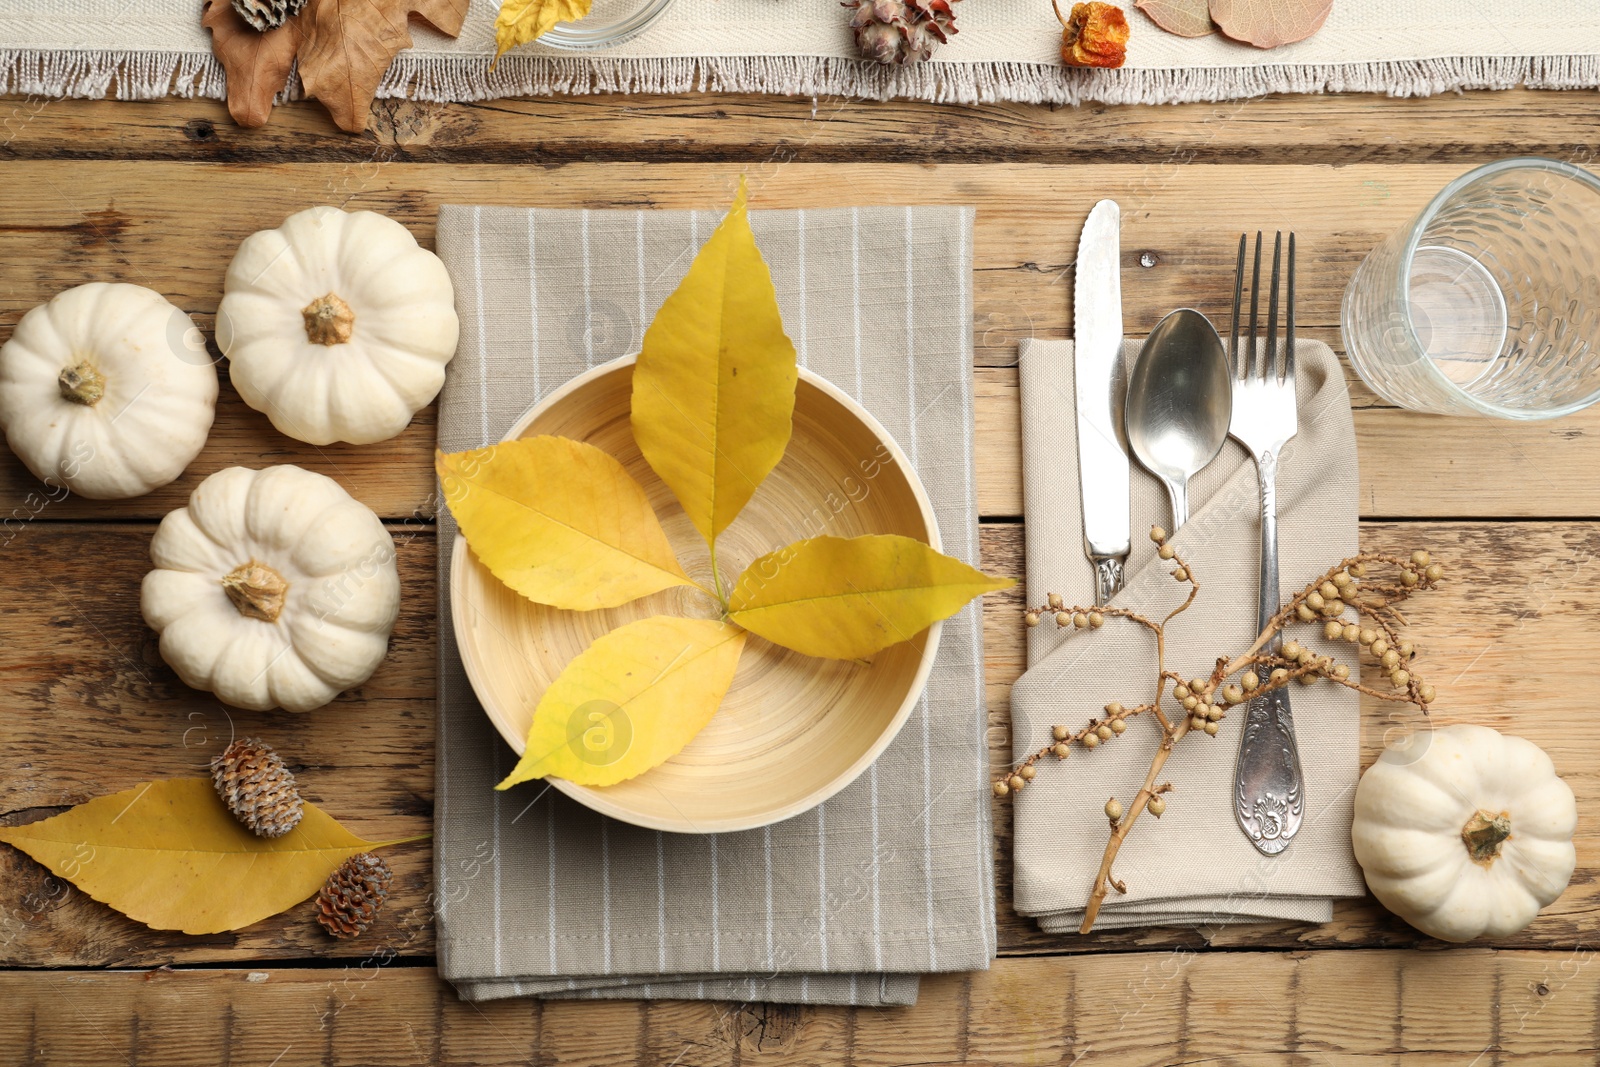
{"left": 450, "top": 357, "right": 942, "bottom": 833}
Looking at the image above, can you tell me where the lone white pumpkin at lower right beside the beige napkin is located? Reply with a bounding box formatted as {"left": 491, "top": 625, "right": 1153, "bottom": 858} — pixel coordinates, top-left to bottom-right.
{"left": 1350, "top": 725, "right": 1578, "bottom": 941}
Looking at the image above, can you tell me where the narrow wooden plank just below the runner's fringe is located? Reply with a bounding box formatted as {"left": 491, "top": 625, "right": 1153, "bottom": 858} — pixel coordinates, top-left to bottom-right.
{"left": 0, "top": 90, "right": 1600, "bottom": 168}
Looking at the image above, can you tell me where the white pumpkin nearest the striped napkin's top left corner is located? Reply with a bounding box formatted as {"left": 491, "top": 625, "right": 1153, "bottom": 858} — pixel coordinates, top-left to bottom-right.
{"left": 216, "top": 208, "right": 459, "bottom": 445}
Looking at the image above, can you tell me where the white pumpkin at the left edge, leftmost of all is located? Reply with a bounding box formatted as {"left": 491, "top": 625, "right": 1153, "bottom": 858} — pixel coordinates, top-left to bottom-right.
{"left": 0, "top": 282, "right": 216, "bottom": 499}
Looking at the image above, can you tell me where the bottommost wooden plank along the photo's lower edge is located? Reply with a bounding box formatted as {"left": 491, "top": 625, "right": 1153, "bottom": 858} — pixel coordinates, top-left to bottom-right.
{"left": 0, "top": 947, "right": 1600, "bottom": 1067}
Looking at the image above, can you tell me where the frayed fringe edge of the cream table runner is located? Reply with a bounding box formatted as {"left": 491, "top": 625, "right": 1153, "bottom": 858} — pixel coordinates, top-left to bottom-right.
{"left": 0, "top": 50, "right": 1600, "bottom": 104}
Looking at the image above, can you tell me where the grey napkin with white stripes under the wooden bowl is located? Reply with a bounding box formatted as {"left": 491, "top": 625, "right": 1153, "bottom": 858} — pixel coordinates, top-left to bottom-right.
{"left": 434, "top": 204, "right": 995, "bottom": 1005}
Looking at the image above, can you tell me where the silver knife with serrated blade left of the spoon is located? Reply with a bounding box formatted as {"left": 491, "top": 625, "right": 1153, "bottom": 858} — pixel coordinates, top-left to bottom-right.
{"left": 1072, "top": 200, "right": 1131, "bottom": 603}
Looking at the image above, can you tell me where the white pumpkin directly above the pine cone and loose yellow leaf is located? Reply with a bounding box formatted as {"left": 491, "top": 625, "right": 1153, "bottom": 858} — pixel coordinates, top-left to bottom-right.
{"left": 141, "top": 466, "right": 400, "bottom": 712}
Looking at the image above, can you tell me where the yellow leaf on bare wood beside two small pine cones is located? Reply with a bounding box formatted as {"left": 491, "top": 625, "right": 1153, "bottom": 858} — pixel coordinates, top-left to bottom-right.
{"left": 0, "top": 777, "right": 412, "bottom": 934}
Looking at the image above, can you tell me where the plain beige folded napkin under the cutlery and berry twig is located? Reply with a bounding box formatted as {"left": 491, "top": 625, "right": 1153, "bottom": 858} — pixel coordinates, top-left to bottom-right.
{"left": 1011, "top": 341, "right": 1363, "bottom": 933}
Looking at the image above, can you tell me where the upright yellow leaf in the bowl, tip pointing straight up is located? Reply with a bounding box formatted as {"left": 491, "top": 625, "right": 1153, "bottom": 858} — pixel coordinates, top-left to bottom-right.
{"left": 634, "top": 179, "right": 798, "bottom": 542}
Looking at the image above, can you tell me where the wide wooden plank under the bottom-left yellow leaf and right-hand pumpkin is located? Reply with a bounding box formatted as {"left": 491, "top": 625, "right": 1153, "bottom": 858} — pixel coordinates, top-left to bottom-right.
{"left": 0, "top": 522, "right": 1600, "bottom": 966}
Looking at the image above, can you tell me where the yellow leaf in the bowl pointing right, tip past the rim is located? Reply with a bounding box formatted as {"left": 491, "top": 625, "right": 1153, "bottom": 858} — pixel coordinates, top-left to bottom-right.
{"left": 728, "top": 534, "right": 1016, "bottom": 659}
